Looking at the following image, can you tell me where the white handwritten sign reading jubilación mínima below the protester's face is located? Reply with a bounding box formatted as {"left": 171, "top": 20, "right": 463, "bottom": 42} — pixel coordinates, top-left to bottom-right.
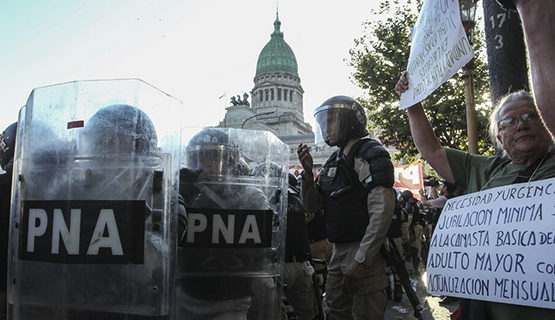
{"left": 427, "top": 178, "right": 555, "bottom": 309}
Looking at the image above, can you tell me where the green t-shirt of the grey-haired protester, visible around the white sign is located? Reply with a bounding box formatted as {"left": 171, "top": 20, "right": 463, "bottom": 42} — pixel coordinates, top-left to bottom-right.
{"left": 446, "top": 149, "right": 555, "bottom": 320}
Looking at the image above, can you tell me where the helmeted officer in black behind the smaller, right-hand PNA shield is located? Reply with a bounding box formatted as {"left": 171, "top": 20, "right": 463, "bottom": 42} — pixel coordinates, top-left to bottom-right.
{"left": 177, "top": 128, "right": 285, "bottom": 320}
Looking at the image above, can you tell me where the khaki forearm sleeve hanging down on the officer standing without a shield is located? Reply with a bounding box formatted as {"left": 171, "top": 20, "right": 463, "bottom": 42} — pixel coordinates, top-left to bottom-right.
{"left": 355, "top": 186, "right": 395, "bottom": 266}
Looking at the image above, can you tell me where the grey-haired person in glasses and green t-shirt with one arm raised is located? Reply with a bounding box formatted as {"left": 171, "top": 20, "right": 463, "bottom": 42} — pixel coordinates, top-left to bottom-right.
{"left": 395, "top": 72, "right": 555, "bottom": 320}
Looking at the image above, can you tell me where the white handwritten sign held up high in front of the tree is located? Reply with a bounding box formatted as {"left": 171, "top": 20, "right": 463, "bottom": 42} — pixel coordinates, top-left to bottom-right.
{"left": 399, "top": 0, "right": 474, "bottom": 110}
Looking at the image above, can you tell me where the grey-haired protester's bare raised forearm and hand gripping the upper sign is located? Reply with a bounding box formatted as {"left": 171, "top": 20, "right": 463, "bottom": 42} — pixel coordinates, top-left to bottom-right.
{"left": 395, "top": 71, "right": 454, "bottom": 182}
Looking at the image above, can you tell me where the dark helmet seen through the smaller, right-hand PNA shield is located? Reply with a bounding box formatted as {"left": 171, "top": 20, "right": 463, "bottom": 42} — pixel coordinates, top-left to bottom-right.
{"left": 187, "top": 128, "right": 240, "bottom": 178}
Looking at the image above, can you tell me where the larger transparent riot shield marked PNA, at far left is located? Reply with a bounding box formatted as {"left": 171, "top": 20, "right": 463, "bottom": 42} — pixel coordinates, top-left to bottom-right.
{"left": 8, "top": 79, "right": 182, "bottom": 320}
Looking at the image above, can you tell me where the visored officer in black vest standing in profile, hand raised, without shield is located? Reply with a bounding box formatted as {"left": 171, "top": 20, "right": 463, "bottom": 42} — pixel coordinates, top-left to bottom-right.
{"left": 297, "top": 96, "right": 395, "bottom": 320}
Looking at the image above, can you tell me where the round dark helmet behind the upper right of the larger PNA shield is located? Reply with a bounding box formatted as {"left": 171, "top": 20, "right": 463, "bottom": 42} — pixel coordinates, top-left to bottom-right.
{"left": 83, "top": 104, "right": 158, "bottom": 155}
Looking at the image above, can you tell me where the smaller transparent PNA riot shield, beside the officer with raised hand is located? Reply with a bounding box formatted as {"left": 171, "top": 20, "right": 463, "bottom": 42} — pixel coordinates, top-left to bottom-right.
{"left": 176, "top": 128, "right": 289, "bottom": 320}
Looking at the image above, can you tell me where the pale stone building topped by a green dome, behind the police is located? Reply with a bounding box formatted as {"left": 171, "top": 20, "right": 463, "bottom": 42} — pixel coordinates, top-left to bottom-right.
{"left": 219, "top": 13, "right": 332, "bottom": 172}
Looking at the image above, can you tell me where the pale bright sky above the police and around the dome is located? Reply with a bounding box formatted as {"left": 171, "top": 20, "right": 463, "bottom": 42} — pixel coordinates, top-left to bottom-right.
{"left": 0, "top": 0, "right": 386, "bottom": 130}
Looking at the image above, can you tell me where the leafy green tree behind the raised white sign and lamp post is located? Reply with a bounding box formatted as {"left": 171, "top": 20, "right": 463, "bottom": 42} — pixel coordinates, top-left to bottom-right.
{"left": 347, "top": 0, "right": 493, "bottom": 159}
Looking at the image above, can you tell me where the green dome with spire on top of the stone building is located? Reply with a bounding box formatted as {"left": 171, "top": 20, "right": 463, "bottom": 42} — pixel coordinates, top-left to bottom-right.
{"left": 255, "top": 14, "right": 299, "bottom": 77}
